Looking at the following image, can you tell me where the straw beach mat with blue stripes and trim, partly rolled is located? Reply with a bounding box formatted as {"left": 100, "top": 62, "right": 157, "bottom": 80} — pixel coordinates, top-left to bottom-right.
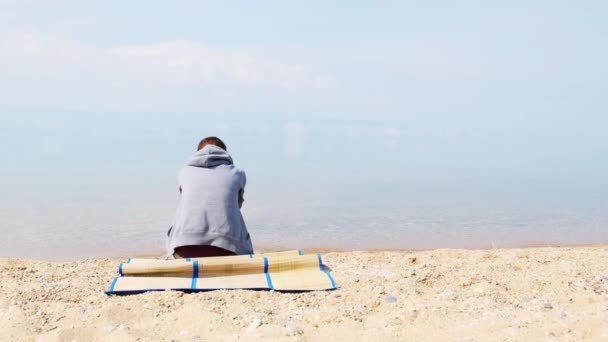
{"left": 105, "top": 251, "right": 336, "bottom": 295}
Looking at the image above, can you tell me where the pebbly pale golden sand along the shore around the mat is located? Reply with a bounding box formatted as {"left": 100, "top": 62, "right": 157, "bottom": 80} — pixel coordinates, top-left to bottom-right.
{"left": 0, "top": 246, "right": 608, "bottom": 341}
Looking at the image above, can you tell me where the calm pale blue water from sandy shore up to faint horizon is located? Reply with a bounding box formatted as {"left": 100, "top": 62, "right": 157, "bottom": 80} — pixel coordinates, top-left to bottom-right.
{"left": 0, "top": 111, "right": 608, "bottom": 259}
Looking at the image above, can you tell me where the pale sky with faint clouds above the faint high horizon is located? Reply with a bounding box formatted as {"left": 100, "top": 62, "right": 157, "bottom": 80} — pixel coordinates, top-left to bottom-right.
{"left": 0, "top": 0, "right": 608, "bottom": 114}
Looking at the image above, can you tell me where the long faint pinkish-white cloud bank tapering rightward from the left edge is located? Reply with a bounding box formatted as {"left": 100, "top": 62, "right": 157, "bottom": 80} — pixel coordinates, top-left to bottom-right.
{"left": 0, "top": 32, "right": 335, "bottom": 89}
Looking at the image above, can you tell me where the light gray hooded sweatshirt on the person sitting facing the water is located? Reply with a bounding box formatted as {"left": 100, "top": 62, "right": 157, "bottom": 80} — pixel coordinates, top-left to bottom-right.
{"left": 167, "top": 145, "right": 253, "bottom": 255}
